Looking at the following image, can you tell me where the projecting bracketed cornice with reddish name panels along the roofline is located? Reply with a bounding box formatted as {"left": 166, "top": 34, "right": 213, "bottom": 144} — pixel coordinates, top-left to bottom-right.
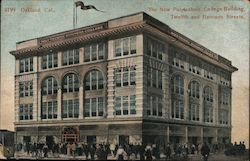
{"left": 10, "top": 15, "right": 238, "bottom": 72}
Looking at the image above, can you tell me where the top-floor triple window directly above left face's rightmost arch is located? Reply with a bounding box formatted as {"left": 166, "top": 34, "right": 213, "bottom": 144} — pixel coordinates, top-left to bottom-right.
{"left": 84, "top": 43, "right": 105, "bottom": 62}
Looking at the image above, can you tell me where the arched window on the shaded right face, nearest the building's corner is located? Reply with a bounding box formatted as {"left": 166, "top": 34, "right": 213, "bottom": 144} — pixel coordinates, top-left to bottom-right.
{"left": 171, "top": 75, "right": 184, "bottom": 95}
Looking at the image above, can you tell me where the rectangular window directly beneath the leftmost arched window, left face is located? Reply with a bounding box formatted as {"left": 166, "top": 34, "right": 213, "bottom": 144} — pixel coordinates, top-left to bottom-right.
{"left": 42, "top": 101, "right": 57, "bottom": 119}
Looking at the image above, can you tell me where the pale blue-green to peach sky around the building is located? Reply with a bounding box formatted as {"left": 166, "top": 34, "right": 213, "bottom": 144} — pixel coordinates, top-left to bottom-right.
{"left": 0, "top": 0, "right": 250, "bottom": 146}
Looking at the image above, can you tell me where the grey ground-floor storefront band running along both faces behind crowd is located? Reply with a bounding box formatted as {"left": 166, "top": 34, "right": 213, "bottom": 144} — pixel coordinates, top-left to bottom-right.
{"left": 16, "top": 121, "right": 231, "bottom": 146}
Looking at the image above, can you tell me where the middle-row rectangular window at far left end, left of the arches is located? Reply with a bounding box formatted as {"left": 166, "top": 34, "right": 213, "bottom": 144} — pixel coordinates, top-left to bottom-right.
{"left": 19, "top": 81, "right": 33, "bottom": 97}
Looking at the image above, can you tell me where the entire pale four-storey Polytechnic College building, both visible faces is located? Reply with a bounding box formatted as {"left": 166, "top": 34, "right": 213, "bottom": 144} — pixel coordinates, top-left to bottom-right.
{"left": 10, "top": 12, "right": 237, "bottom": 144}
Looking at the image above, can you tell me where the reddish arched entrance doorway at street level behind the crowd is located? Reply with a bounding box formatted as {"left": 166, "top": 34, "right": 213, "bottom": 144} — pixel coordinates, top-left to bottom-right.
{"left": 62, "top": 127, "right": 79, "bottom": 143}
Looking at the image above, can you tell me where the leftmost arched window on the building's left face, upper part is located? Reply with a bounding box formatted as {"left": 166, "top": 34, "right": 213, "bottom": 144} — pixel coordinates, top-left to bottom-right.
{"left": 41, "top": 76, "right": 57, "bottom": 95}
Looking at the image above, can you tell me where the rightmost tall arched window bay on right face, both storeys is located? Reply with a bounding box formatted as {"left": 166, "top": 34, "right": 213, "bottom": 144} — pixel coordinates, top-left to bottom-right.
{"left": 203, "top": 87, "right": 213, "bottom": 122}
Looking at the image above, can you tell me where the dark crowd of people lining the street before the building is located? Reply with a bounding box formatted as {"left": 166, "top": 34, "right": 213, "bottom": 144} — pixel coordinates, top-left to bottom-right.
{"left": 16, "top": 142, "right": 245, "bottom": 160}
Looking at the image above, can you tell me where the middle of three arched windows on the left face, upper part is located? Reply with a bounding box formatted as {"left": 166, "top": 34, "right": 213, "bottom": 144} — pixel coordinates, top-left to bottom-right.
{"left": 62, "top": 73, "right": 79, "bottom": 93}
